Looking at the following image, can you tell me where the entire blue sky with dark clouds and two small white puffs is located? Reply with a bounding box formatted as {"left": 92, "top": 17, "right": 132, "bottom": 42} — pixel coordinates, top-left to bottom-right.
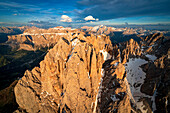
{"left": 0, "top": 0, "right": 170, "bottom": 26}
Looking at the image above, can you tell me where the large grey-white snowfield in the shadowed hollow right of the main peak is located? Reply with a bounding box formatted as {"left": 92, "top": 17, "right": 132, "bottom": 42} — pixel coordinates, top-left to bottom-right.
{"left": 125, "top": 58, "right": 156, "bottom": 113}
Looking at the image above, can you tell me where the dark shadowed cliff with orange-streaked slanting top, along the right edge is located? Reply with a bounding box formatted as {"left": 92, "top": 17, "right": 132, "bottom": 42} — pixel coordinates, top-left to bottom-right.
{"left": 141, "top": 33, "right": 170, "bottom": 113}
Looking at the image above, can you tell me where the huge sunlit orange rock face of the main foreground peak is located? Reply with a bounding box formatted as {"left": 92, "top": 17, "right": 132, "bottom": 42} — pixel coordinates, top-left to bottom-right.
{"left": 15, "top": 32, "right": 119, "bottom": 113}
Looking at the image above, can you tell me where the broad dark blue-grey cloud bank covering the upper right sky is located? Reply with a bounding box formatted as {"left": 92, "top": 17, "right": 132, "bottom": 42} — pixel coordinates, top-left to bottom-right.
{"left": 78, "top": 0, "right": 170, "bottom": 20}
